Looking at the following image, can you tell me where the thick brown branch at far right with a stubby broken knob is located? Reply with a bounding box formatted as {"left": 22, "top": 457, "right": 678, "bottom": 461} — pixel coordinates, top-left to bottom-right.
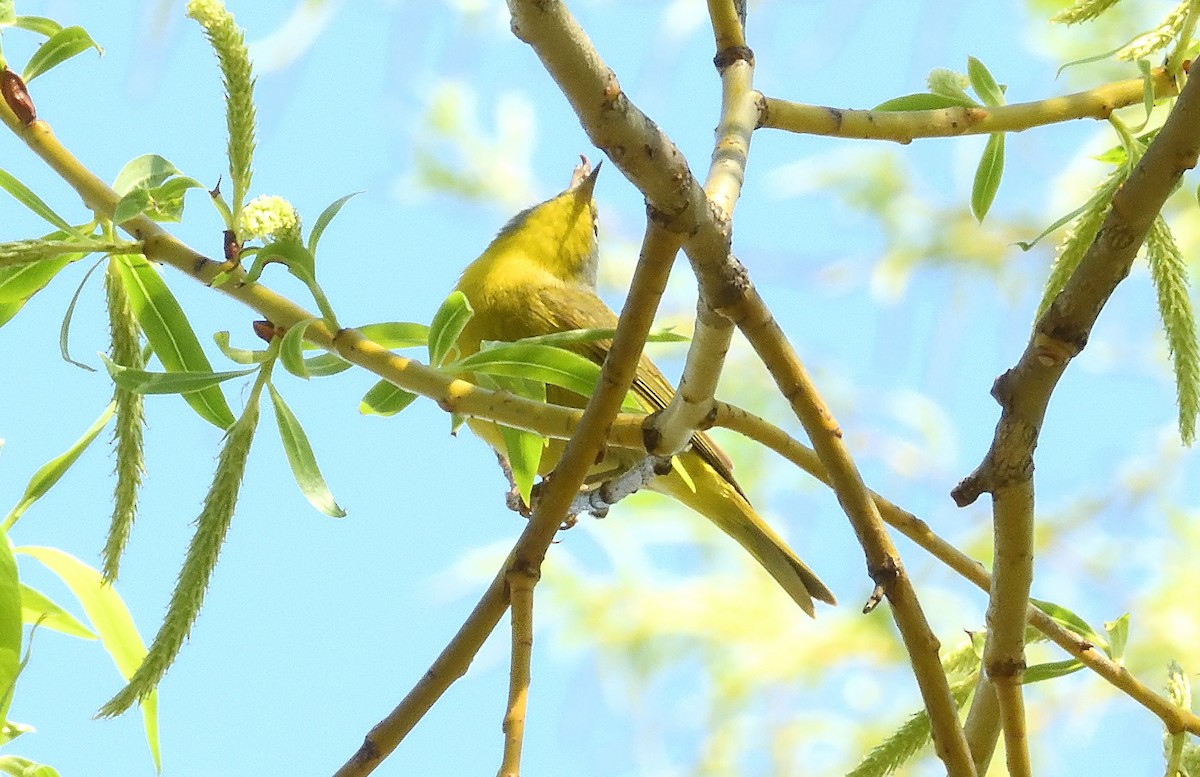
{"left": 952, "top": 63, "right": 1200, "bottom": 775}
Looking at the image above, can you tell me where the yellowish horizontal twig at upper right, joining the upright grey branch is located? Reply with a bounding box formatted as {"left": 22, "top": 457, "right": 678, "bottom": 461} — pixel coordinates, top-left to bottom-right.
{"left": 760, "top": 67, "right": 1178, "bottom": 143}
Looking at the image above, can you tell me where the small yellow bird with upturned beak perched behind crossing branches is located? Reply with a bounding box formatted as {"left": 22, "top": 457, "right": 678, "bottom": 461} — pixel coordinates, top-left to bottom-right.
{"left": 457, "top": 159, "right": 834, "bottom": 615}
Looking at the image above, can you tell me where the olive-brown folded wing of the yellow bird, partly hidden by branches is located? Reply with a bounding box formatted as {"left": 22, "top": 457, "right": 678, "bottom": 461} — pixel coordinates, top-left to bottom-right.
{"left": 538, "top": 288, "right": 745, "bottom": 496}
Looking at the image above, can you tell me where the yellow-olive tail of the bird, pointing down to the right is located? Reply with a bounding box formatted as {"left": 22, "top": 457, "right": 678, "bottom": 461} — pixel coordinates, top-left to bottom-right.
{"left": 650, "top": 453, "right": 836, "bottom": 615}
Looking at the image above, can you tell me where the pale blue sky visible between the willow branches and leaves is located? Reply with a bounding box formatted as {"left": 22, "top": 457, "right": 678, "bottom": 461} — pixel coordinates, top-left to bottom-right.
{"left": 0, "top": 0, "right": 1196, "bottom": 777}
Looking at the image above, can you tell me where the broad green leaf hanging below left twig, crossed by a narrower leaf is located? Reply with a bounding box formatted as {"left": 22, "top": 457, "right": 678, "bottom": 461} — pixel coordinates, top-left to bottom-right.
{"left": 113, "top": 255, "right": 234, "bottom": 429}
